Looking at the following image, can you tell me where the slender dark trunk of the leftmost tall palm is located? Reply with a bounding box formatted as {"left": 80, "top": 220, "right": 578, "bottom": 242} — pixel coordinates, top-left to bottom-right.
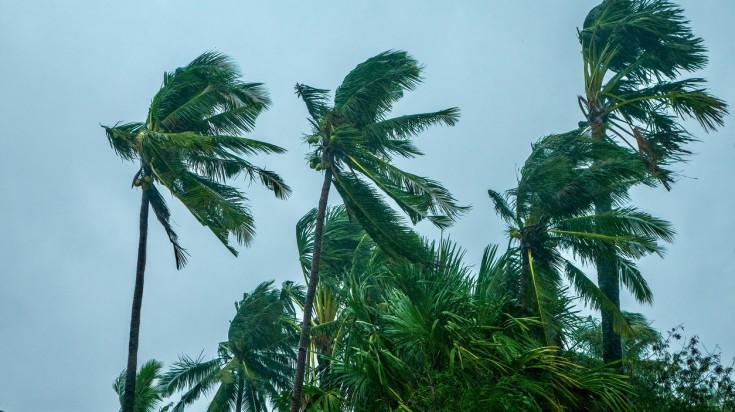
{"left": 122, "top": 190, "right": 149, "bottom": 412}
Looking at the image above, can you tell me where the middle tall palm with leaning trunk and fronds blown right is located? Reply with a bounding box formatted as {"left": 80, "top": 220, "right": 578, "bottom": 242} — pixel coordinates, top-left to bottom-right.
{"left": 291, "top": 51, "right": 465, "bottom": 412}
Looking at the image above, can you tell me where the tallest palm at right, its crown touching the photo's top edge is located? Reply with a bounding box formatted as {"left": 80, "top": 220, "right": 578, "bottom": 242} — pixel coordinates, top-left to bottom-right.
{"left": 578, "top": 0, "right": 727, "bottom": 362}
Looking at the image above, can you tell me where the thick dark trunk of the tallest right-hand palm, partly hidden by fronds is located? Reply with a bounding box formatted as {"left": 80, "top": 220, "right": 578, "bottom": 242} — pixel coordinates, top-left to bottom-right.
{"left": 590, "top": 111, "right": 623, "bottom": 372}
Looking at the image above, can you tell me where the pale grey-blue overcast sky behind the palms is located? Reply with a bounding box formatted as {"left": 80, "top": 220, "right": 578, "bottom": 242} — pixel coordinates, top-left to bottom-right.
{"left": 0, "top": 0, "right": 735, "bottom": 412}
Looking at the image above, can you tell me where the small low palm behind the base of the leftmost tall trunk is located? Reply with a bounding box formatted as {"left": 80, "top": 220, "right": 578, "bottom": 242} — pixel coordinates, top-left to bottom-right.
{"left": 112, "top": 359, "right": 173, "bottom": 412}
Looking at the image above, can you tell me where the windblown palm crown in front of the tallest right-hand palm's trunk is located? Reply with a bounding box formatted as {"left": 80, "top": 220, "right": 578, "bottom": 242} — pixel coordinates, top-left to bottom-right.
{"left": 488, "top": 130, "right": 673, "bottom": 346}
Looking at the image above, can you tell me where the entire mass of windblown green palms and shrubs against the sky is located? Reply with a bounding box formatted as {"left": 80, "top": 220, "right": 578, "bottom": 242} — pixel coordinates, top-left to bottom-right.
{"left": 103, "top": 0, "right": 735, "bottom": 412}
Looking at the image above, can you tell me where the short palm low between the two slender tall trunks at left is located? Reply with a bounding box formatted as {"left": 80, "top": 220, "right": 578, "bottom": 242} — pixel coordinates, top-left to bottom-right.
{"left": 160, "top": 281, "right": 297, "bottom": 412}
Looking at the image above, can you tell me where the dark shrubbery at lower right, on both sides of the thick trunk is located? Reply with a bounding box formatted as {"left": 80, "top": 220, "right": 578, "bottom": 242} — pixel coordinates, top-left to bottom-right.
{"left": 564, "top": 313, "right": 735, "bottom": 412}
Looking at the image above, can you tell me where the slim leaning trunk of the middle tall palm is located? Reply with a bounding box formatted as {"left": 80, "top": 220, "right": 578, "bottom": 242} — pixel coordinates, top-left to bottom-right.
{"left": 290, "top": 167, "right": 332, "bottom": 412}
